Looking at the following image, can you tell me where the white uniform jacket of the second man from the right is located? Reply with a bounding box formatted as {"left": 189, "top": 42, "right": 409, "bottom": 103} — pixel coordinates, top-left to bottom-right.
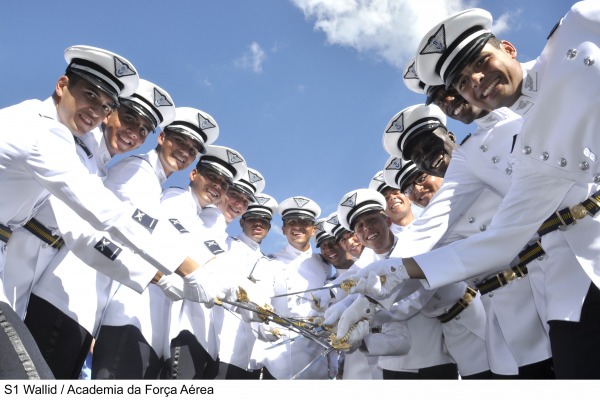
{"left": 401, "top": 109, "right": 551, "bottom": 375}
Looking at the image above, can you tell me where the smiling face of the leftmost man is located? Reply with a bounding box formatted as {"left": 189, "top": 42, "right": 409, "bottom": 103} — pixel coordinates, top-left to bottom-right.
{"left": 55, "top": 75, "right": 113, "bottom": 135}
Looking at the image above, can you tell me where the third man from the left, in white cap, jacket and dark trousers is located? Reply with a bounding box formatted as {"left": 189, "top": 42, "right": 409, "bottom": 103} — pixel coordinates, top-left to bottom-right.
{"left": 92, "top": 111, "right": 225, "bottom": 379}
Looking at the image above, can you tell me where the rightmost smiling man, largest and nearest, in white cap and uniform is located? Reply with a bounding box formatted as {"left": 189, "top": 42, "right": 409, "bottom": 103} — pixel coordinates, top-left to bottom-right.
{"left": 352, "top": 1, "right": 600, "bottom": 379}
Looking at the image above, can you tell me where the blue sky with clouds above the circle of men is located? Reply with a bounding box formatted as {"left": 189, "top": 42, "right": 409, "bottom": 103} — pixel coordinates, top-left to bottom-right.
{"left": 0, "top": 0, "right": 573, "bottom": 252}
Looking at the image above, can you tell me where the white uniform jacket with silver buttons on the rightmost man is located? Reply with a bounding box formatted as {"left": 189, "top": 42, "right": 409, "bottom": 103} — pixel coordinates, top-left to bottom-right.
{"left": 415, "top": 1, "right": 600, "bottom": 321}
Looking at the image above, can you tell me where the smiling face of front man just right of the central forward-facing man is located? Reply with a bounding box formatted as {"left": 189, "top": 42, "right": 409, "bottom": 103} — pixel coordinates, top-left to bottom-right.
{"left": 354, "top": 211, "right": 394, "bottom": 254}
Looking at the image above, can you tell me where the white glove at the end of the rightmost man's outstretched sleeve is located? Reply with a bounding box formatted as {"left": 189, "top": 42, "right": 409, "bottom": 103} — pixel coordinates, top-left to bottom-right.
{"left": 351, "top": 259, "right": 410, "bottom": 297}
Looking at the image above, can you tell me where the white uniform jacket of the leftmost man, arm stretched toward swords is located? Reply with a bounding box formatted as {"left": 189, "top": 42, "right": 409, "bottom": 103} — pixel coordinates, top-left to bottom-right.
{"left": 0, "top": 100, "right": 186, "bottom": 286}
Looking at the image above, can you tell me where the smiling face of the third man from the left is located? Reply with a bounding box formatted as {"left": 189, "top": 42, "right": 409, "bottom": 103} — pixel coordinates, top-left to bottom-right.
{"left": 158, "top": 131, "right": 199, "bottom": 176}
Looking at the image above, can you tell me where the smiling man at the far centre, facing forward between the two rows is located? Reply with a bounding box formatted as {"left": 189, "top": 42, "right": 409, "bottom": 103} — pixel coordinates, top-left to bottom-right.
{"left": 254, "top": 196, "right": 330, "bottom": 379}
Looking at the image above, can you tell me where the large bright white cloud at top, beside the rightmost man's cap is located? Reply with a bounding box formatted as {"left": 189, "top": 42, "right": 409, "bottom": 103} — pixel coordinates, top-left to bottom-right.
{"left": 291, "top": 0, "right": 509, "bottom": 69}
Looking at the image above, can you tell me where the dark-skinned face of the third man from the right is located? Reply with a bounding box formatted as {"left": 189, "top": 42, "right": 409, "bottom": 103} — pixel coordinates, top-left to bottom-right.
{"left": 404, "top": 127, "right": 456, "bottom": 176}
